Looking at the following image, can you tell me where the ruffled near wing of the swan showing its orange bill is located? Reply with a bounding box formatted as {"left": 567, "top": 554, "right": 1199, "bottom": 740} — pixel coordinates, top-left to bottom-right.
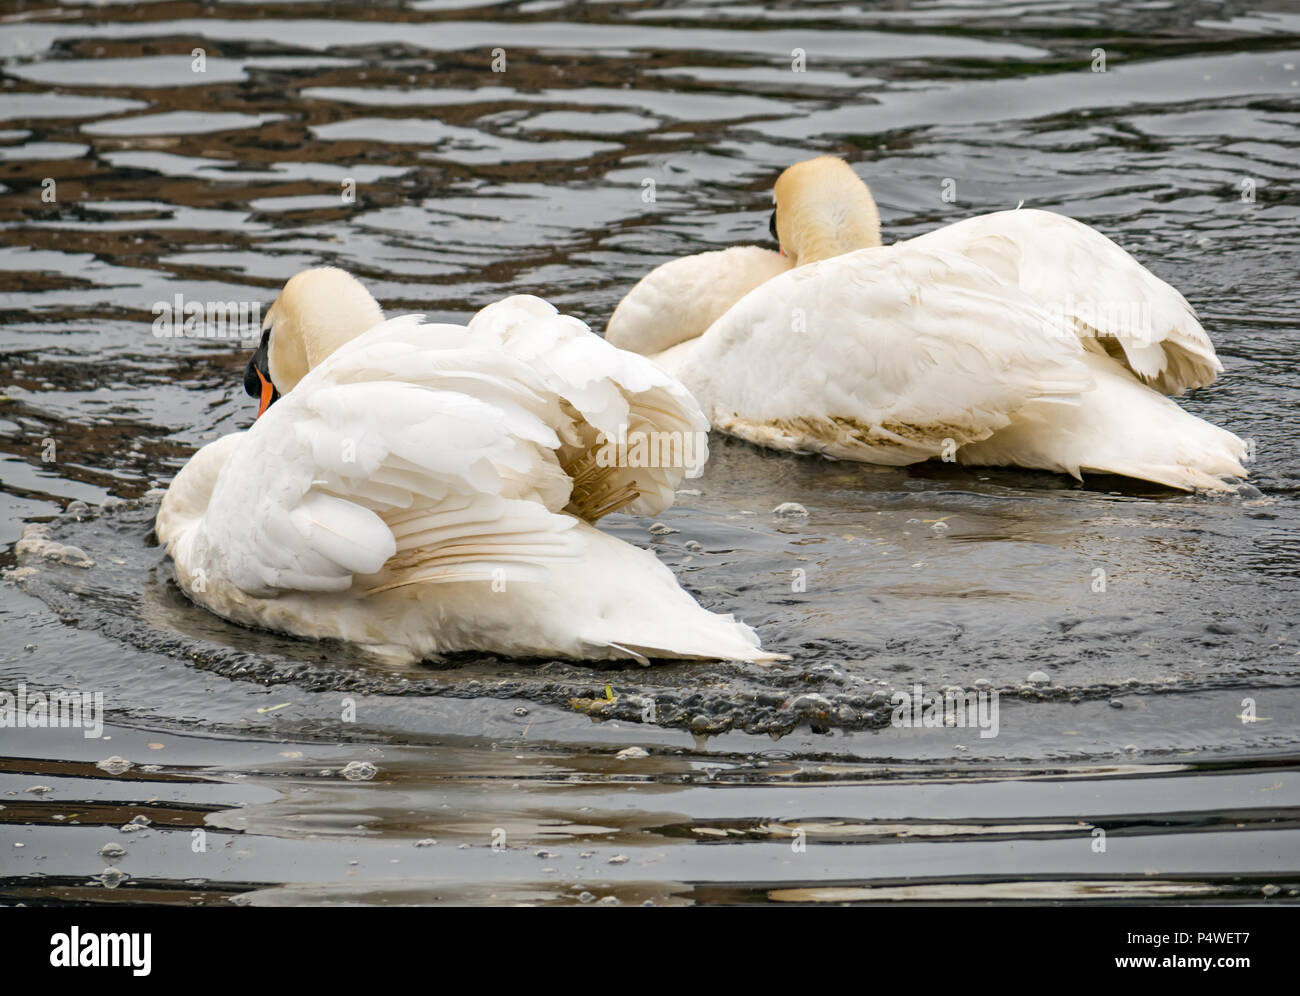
{"left": 185, "top": 316, "right": 575, "bottom": 597}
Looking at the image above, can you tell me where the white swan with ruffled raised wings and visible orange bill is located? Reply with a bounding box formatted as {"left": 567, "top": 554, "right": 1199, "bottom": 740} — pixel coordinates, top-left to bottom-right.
{"left": 156, "top": 268, "right": 780, "bottom": 662}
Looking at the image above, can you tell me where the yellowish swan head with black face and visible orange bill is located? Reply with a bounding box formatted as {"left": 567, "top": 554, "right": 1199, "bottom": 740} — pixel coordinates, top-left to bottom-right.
{"left": 244, "top": 267, "right": 384, "bottom": 417}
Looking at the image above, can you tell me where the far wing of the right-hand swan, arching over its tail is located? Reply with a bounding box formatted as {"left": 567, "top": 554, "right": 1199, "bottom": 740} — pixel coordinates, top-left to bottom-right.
{"left": 904, "top": 209, "right": 1223, "bottom": 395}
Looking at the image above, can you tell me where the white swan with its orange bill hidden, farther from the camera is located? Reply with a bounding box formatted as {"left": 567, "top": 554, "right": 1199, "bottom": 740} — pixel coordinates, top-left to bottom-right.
{"left": 606, "top": 156, "right": 1245, "bottom": 490}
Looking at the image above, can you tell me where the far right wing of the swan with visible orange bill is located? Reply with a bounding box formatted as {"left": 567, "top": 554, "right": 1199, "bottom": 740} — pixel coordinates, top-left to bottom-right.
{"left": 469, "top": 294, "right": 709, "bottom": 521}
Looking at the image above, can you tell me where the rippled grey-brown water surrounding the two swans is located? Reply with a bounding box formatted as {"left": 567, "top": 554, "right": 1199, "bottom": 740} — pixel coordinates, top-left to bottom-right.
{"left": 0, "top": 0, "right": 1300, "bottom": 905}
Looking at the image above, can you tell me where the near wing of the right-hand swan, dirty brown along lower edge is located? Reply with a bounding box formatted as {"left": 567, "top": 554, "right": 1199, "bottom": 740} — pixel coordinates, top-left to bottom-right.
{"left": 681, "top": 246, "right": 1091, "bottom": 465}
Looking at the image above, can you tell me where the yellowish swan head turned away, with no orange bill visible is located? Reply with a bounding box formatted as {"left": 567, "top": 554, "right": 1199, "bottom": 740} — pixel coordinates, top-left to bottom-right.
{"left": 771, "top": 156, "right": 880, "bottom": 267}
